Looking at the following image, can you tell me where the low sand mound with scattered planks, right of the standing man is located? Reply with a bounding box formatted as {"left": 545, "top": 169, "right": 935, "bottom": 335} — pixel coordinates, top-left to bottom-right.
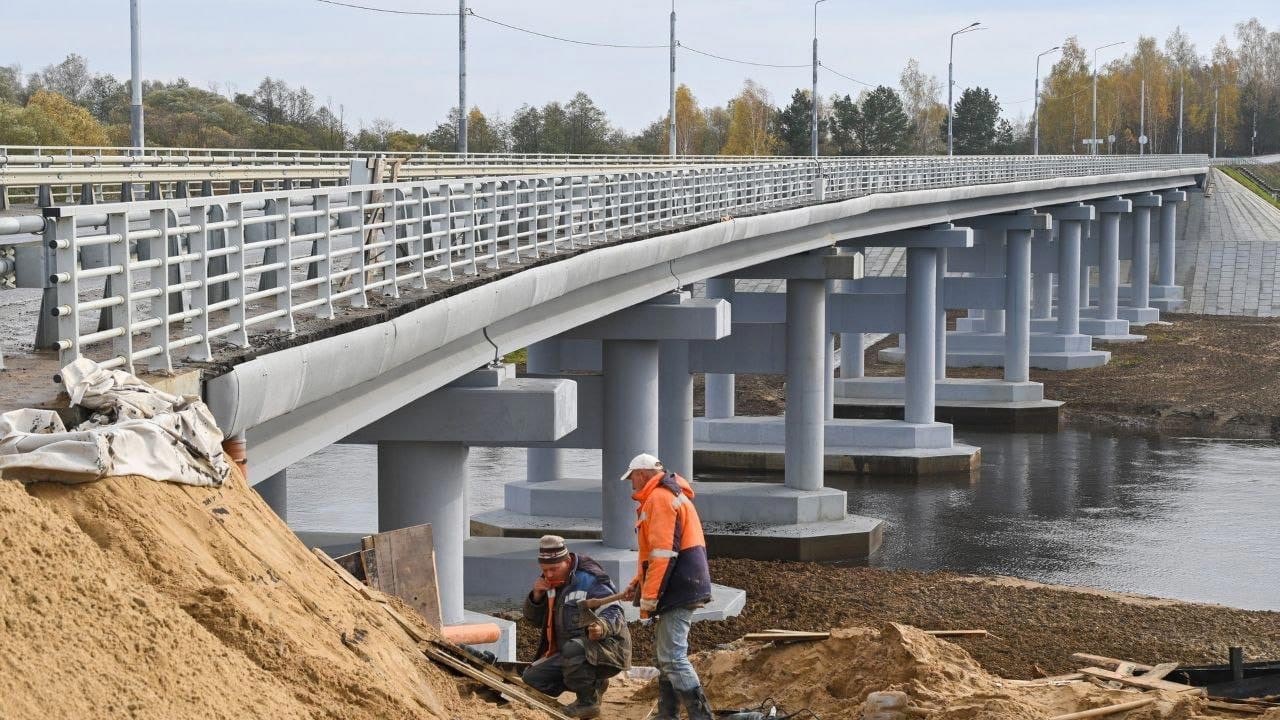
{"left": 655, "top": 623, "right": 1264, "bottom": 720}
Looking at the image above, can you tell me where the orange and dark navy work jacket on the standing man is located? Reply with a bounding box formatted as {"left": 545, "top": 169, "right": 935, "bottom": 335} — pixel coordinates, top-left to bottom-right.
{"left": 631, "top": 473, "right": 712, "bottom": 615}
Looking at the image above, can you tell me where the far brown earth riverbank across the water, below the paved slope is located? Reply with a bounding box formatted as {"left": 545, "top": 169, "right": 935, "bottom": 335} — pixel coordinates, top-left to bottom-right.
{"left": 695, "top": 314, "right": 1280, "bottom": 439}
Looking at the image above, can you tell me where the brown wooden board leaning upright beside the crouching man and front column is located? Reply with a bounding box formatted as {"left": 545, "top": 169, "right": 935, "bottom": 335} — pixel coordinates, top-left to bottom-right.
{"left": 365, "top": 525, "right": 442, "bottom": 628}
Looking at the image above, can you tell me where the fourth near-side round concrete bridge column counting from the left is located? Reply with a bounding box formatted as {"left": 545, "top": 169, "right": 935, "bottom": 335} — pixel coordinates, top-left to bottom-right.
{"left": 904, "top": 247, "right": 938, "bottom": 423}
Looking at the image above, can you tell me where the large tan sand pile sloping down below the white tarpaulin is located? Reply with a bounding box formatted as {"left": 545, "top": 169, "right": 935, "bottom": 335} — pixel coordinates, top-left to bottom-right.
{"left": 0, "top": 473, "right": 535, "bottom": 720}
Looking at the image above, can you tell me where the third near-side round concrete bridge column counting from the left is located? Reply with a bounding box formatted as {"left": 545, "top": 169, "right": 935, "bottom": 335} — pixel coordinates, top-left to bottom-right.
{"left": 783, "top": 275, "right": 824, "bottom": 489}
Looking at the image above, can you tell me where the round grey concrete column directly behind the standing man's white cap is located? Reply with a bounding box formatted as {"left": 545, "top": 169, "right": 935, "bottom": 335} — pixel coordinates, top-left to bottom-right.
{"left": 600, "top": 340, "right": 660, "bottom": 550}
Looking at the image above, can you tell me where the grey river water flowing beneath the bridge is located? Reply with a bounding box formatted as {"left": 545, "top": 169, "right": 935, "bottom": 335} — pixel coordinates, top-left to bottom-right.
{"left": 289, "top": 430, "right": 1280, "bottom": 610}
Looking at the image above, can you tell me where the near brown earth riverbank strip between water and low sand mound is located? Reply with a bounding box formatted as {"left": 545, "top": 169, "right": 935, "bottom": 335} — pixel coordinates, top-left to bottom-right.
{"left": 518, "top": 559, "right": 1280, "bottom": 679}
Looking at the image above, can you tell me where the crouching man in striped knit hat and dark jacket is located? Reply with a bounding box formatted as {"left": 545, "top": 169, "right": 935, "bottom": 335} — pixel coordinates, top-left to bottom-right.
{"left": 522, "top": 536, "right": 631, "bottom": 717}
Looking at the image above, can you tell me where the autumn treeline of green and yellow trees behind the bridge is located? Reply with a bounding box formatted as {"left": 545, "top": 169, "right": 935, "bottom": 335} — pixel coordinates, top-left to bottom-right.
{"left": 0, "top": 19, "right": 1280, "bottom": 155}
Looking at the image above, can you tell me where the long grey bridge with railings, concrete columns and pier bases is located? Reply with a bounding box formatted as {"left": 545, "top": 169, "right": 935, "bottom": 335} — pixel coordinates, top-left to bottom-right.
{"left": 0, "top": 151, "right": 1211, "bottom": 655}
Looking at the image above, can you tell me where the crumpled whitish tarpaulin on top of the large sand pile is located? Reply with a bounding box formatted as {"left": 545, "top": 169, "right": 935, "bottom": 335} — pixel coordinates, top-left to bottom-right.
{"left": 0, "top": 357, "right": 230, "bottom": 486}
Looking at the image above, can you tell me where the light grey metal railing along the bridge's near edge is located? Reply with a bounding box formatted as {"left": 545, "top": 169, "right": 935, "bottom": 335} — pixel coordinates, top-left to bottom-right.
{"left": 44, "top": 155, "right": 1207, "bottom": 370}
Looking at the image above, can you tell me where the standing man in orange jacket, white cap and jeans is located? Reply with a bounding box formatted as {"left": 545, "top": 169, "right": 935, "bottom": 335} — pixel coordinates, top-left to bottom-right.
{"left": 622, "top": 454, "right": 712, "bottom": 720}
